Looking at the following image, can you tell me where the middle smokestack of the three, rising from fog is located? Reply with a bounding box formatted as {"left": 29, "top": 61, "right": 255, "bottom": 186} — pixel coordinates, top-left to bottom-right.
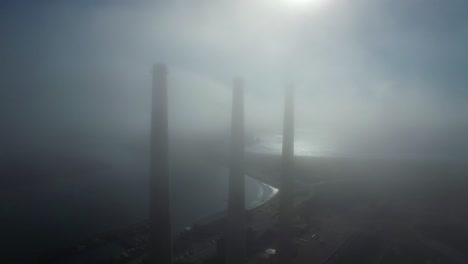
{"left": 226, "top": 79, "right": 246, "bottom": 264}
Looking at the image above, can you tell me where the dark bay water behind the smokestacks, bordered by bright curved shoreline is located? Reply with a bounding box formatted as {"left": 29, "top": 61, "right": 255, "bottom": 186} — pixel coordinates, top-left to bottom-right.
{"left": 0, "top": 146, "right": 277, "bottom": 263}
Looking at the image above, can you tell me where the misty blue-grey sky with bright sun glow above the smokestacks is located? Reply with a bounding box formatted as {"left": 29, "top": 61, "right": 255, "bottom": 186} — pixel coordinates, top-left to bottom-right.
{"left": 0, "top": 0, "right": 468, "bottom": 157}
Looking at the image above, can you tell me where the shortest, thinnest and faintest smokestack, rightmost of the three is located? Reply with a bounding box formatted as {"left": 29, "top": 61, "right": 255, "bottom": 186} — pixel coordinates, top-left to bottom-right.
{"left": 278, "top": 86, "right": 294, "bottom": 264}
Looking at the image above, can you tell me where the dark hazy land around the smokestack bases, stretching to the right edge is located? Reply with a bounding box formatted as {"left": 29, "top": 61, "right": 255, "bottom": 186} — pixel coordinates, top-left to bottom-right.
{"left": 37, "top": 154, "right": 468, "bottom": 264}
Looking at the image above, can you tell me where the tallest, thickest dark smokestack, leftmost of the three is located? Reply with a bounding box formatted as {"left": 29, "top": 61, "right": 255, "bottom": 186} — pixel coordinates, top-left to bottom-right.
{"left": 149, "top": 64, "right": 173, "bottom": 264}
